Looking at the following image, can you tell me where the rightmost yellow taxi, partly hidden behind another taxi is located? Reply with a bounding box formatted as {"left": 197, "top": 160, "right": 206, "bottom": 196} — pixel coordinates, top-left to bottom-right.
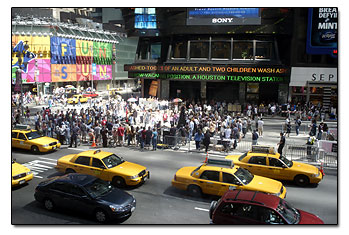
{"left": 225, "top": 145, "right": 324, "bottom": 186}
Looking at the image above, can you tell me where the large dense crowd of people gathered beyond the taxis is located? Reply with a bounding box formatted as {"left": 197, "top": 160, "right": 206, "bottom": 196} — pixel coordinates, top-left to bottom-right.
{"left": 12, "top": 89, "right": 334, "bottom": 151}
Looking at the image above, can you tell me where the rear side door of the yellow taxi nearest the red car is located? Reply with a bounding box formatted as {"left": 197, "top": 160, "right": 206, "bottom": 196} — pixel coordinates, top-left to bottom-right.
{"left": 197, "top": 170, "right": 221, "bottom": 195}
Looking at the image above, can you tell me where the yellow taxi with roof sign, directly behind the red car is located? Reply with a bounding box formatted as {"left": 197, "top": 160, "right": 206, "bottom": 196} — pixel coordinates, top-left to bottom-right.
{"left": 172, "top": 158, "right": 286, "bottom": 198}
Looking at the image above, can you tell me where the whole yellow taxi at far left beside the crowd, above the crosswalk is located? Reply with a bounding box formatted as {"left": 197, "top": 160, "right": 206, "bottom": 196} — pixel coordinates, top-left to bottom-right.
{"left": 12, "top": 125, "right": 61, "bottom": 153}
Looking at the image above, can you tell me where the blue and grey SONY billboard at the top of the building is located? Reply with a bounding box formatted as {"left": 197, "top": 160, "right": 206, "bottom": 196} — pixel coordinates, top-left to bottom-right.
{"left": 187, "top": 8, "right": 261, "bottom": 25}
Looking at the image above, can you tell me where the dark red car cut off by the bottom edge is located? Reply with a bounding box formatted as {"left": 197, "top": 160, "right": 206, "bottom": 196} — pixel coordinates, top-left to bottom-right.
{"left": 209, "top": 190, "right": 324, "bottom": 224}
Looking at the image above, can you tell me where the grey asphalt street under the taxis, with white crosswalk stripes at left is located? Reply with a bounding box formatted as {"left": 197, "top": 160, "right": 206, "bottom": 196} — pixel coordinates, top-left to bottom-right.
{"left": 11, "top": 142, "right": 338, "bottom": 225}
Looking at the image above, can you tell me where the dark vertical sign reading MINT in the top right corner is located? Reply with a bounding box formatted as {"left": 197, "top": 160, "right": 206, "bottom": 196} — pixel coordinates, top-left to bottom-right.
{"left": 307, "top": 7, "right": 338, "bottom": 57}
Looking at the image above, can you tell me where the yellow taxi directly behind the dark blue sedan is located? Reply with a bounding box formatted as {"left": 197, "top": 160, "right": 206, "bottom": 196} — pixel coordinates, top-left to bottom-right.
{"left": 56, "top": 150, "right": 150, "bottom": 187}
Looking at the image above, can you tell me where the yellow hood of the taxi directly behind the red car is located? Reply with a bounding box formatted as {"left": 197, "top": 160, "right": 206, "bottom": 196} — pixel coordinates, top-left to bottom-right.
{"left": 245, "top": 175, "right": 282, "bottom": 194}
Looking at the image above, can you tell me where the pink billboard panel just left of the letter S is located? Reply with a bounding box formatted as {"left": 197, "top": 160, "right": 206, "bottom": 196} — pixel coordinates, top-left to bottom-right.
{"left": 22, "top": 59, "right": 51, "bottom": 83}
